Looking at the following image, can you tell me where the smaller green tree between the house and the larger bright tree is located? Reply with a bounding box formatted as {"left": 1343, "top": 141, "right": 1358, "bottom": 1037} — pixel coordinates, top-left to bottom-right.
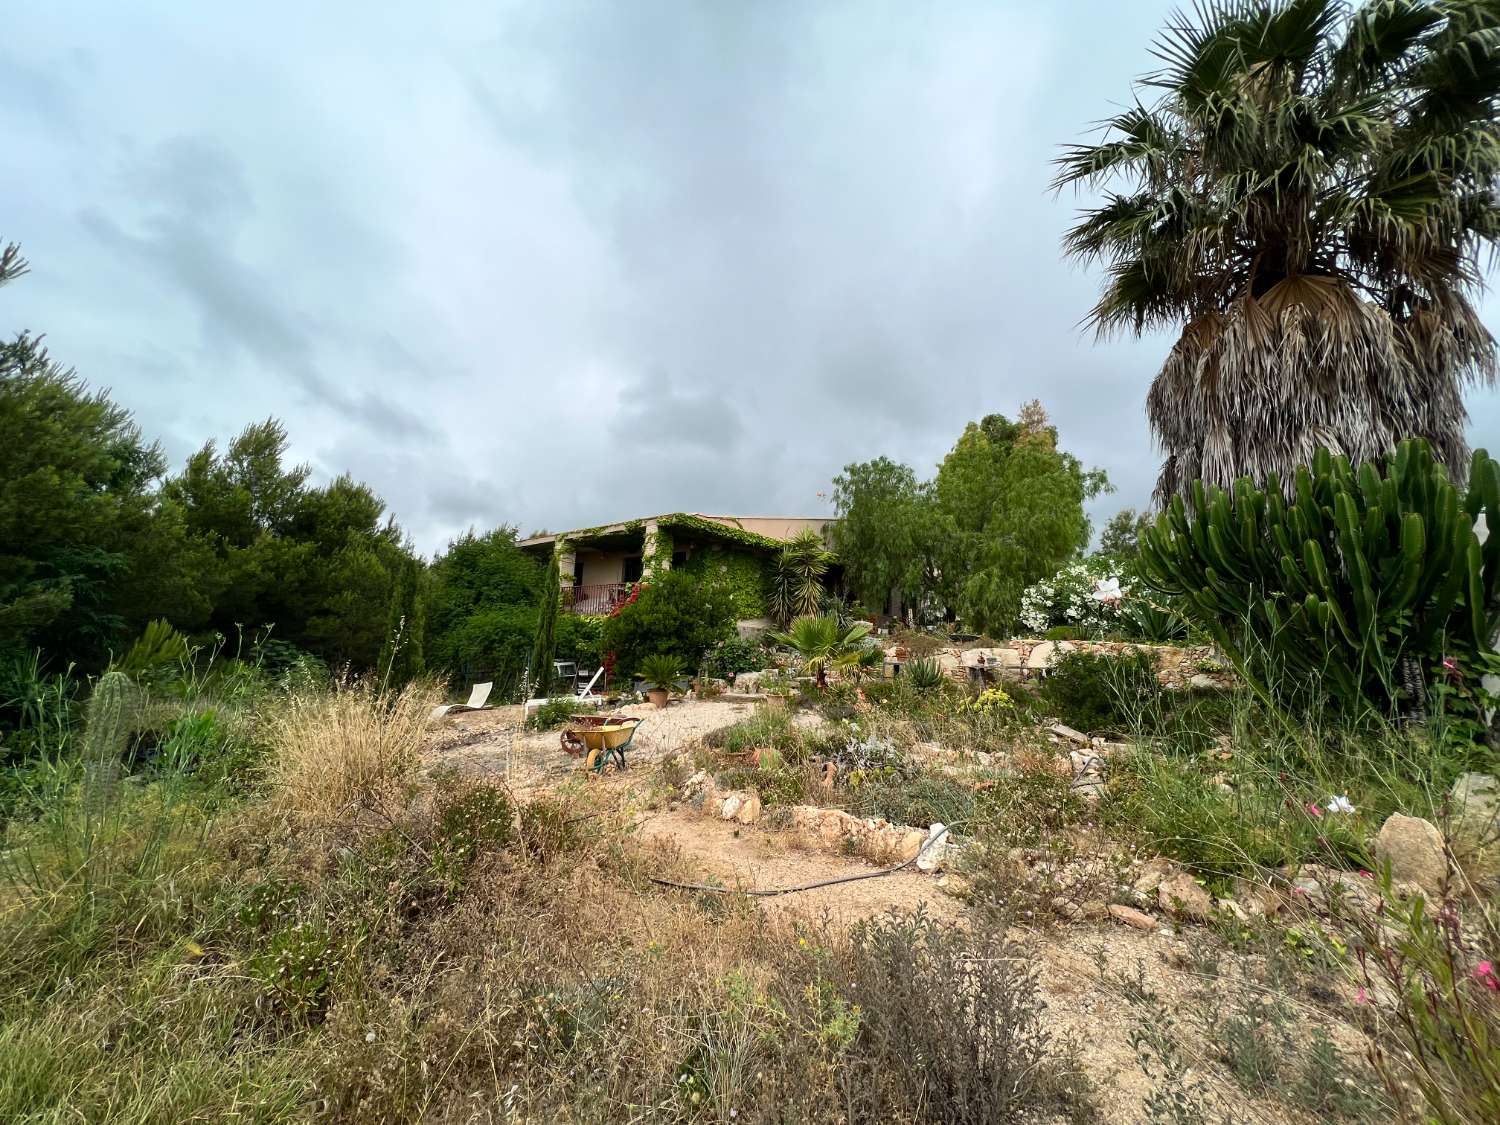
{"left": 834, "top": 458, "right": 936, "bottom": 611}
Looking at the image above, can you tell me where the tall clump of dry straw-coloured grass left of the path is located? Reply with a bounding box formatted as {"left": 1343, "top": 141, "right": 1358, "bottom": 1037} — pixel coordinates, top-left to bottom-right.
{"left": 266, "top": 681, "right": 441, "bottom": 821}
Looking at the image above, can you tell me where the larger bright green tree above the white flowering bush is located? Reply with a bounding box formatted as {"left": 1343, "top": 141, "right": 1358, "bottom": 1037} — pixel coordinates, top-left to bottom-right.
{"left": 932, "top": 404, "right": 1109, "bottom": 635}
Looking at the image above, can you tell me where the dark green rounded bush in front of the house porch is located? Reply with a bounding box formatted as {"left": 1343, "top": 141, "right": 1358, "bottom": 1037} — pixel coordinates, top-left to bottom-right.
{"left": 605, "top": 570, "right": 735, "bottom": 677}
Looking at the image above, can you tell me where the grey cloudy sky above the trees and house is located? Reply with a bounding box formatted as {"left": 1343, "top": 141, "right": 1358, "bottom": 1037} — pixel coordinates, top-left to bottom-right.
{"left": 0, "top": 0, "right": 1500, "bottom": 552}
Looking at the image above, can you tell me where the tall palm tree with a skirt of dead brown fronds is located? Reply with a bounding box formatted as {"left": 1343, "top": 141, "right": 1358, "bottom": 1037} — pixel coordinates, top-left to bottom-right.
{"left": 1055, "top": 0, "right": 1500, "bottom": 501}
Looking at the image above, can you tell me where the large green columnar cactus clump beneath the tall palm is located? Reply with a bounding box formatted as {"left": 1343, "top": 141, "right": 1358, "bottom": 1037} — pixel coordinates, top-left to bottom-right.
{"left": 1142, "top": 441, "right": 1500, "bottom": 714}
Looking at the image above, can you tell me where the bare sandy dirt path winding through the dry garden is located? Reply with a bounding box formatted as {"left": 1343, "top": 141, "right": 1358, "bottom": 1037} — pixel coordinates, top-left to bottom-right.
{"left": 426, "top": 701, "right": 1358, "bottom": 1122}
